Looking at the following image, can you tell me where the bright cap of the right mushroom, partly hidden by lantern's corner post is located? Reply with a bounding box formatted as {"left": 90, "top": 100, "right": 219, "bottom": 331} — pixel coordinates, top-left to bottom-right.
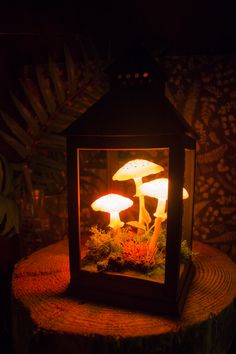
{"left": 140, "top": 178, "right": 189, "bottom": 200}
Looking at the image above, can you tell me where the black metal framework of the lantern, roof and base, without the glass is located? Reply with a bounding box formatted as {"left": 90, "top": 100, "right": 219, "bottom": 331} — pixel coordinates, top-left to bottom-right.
{"left": 66, "top": 45, "right": 196, "bottom": 315}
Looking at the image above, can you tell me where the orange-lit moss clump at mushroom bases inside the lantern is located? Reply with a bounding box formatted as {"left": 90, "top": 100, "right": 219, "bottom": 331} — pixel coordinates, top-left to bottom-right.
{"left": 82, "top": 227, "right": 193, "bottom": 275}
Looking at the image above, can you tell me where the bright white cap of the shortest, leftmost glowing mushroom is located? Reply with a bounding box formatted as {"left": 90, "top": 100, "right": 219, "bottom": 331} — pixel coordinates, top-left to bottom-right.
{"left": 91, "top": 194, "right": 133, "bottom": 213}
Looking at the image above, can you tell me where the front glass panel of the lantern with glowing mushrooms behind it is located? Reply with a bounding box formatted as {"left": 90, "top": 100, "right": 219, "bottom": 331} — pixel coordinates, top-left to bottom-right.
{"left": 77, "top": 148, "right": 169, "bottom": 283}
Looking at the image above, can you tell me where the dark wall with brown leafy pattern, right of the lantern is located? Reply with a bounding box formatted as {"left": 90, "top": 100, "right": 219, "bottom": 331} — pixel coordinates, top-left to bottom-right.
{"left": 163, "top": 56, "right": 236, "bottom": 260}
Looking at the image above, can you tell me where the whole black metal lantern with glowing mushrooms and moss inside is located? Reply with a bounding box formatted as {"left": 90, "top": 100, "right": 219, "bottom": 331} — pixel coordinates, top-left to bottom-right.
{"left": 66, "top": 48, "right": 196, "bottom": 315}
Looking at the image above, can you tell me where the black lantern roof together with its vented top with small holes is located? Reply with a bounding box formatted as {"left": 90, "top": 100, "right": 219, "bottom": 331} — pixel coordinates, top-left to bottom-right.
{"left": 64, "top": 46, "right": 196, "bottom": 138}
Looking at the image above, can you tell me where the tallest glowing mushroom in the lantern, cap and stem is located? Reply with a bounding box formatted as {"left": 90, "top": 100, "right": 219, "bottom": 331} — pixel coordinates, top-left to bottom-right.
{"left": 112, "top": 159, "right": 164, "bottom": 224}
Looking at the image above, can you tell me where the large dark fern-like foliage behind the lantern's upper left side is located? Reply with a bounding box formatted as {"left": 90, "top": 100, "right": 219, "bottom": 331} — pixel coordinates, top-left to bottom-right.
{"left": 0, "top": 48, "right": 106, "bottom": 195}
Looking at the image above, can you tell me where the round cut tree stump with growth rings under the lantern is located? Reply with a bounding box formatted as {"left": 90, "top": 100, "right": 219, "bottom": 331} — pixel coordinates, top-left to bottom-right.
{"left": 12, "top": 240, "right": 236, "bottom": 354}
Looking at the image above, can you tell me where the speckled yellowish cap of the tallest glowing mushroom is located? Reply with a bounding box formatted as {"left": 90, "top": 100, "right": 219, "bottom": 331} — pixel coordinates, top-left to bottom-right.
{"left": 112, "top": 159, "right": 164, "bottom": 181}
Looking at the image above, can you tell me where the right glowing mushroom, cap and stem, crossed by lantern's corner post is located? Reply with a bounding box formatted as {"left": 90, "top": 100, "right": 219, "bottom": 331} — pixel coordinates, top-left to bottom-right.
{"left": 140, "top": 178, "right": 189, "bottom": 258}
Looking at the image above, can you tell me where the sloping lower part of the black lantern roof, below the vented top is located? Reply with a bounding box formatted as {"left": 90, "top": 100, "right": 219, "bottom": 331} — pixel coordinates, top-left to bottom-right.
{"left": 65, "top": 90, "right": 196, "bottom": 137}
